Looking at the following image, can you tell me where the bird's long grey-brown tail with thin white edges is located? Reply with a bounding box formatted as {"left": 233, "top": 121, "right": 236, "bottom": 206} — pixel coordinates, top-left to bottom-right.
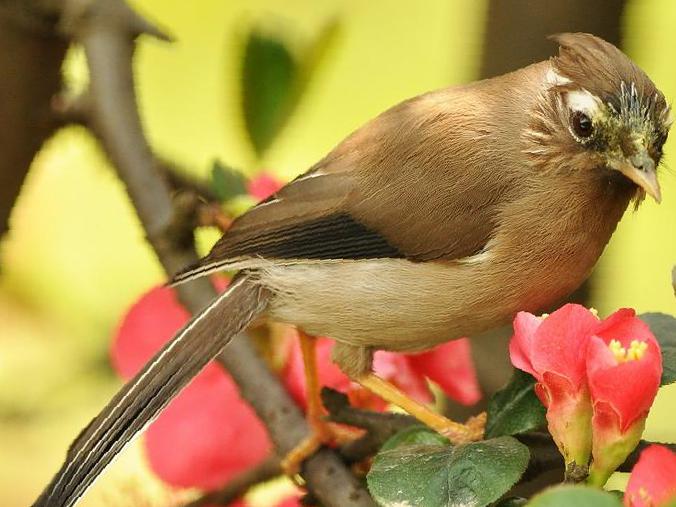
{"left": 33, "top": 275, "right": 269, "bottom": 507}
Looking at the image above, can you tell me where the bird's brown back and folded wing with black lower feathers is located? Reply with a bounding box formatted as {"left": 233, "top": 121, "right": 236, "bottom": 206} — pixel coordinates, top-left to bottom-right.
{"left": 173, "top": 89, "right": 508, "bottom": 283}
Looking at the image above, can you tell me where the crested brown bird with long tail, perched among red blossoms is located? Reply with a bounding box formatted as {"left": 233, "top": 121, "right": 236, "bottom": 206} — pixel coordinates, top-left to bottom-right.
{"left": 35, "top": 34, "right": 672, "bottom": 507}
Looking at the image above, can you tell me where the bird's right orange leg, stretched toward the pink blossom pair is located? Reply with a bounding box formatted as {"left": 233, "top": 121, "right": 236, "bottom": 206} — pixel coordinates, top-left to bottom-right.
{"left": 356, "top": 373, "right": 486, "bottom": 444}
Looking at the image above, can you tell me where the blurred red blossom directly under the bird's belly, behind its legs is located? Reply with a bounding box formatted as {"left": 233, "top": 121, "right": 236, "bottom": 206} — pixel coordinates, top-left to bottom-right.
{"left": 283, "top": 338, "right": 481, "bottom": 410}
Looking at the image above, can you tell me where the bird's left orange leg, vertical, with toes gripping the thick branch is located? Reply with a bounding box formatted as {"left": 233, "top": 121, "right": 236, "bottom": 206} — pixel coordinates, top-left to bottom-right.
{"left": 281, "top": 329, "right": 354, "bottom": 476}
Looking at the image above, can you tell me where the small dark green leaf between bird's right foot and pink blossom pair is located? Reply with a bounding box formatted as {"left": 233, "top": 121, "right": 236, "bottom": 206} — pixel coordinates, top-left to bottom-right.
{"left": 486, "top": 369, "right": 547, "bottom": 438}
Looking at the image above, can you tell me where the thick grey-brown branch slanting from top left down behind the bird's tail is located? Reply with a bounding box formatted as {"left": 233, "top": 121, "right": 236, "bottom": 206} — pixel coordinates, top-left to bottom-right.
{"left": 26, "top": 0, "right": 374, "bottom": 507}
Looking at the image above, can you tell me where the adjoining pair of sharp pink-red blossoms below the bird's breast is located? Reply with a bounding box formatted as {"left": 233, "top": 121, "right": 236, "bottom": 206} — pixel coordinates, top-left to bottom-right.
{"left": 509, "top": 305, "right": 662, "bottom": 486}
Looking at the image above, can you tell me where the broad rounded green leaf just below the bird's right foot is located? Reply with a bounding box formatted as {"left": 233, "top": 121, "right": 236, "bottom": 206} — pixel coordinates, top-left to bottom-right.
{"left": 367, "top": 437, "right": 530, "bottom": 507}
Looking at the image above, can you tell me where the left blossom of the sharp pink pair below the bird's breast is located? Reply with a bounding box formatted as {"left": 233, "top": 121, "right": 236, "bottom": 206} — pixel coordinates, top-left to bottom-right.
{"left": 509, "top": 304, "right": 599, "bottom": 466}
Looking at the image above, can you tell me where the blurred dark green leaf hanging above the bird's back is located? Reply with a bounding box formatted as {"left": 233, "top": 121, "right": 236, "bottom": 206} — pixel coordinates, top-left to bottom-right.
{"left": 242, "top": 31, "right": 298, "bottom": 156}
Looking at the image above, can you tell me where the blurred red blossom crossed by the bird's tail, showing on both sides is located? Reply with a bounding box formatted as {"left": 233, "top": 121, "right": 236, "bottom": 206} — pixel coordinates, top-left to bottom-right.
{"left": 111, "top": 284, "right": 271, "bottom": 489}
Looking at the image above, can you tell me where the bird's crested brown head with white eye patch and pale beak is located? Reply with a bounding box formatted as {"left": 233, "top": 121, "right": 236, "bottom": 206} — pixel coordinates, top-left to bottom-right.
{"left": 524, "top": 33, "right": 673, "bottom": 202}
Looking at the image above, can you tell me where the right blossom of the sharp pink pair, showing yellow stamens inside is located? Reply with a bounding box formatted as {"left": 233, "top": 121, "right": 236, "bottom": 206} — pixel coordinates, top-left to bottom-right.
{"left": 587, "top": 309, "right": 662, "bottom": 486}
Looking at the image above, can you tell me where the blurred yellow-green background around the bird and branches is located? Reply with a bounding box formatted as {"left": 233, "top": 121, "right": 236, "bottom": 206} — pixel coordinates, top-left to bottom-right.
{"left": 0, "top": 0, "right": 676, "bottom": 507}
